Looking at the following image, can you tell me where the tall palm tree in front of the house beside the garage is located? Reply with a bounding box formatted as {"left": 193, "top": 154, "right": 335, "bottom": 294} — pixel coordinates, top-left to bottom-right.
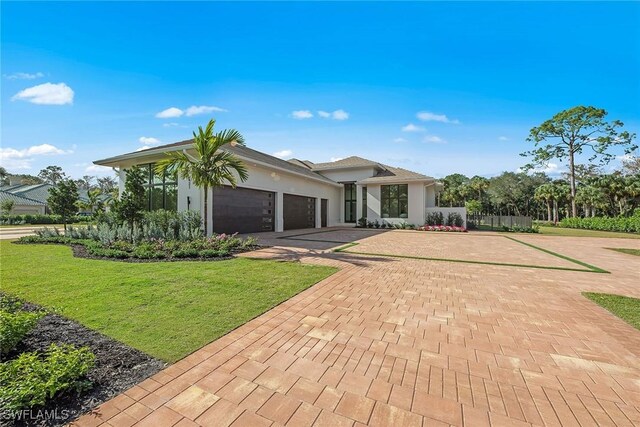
{"left": 156, "top": 119, "right": 249, "bottom": 234}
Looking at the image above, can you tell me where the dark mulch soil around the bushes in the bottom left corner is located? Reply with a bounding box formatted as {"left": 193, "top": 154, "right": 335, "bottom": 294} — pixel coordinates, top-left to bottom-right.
{"left": 0, "top": 303, "right": 166, "bottom": 426}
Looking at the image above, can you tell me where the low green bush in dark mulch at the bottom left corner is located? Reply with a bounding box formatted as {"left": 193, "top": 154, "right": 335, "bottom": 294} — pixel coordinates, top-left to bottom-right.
{"left": 0, "top": 344, "right": 95, "bottom": 411}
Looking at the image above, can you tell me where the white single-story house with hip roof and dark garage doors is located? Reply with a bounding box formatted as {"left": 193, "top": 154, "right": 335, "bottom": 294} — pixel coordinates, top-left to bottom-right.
{"left": 94, "top": 140, "right": 466, "bottom": 233}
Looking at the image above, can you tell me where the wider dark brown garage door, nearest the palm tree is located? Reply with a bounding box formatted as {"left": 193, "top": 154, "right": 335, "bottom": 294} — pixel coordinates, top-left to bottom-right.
{"left": 213, "top": 187, "right": 275, "bottom": 233}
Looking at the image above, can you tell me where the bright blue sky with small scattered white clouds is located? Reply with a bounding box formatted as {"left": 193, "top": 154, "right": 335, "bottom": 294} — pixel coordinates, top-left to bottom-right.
{"left": 1, "top": 2, "right": 640, "bottom": 177}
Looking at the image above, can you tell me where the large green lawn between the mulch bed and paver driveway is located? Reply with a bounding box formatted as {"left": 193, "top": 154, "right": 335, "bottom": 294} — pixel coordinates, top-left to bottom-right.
{"left": 0, "top": 241, "right": 336, "bottom": 362}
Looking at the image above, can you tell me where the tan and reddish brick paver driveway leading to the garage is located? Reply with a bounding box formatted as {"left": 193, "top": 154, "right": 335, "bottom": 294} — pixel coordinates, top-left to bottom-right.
{"left": 77, "top": 230, "right": 640, "bottom": 427}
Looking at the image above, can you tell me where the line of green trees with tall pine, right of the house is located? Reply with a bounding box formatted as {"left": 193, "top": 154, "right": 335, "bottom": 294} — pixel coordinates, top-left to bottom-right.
{"left": 437, "top": 106, "right": 640, "bottom": 222}
